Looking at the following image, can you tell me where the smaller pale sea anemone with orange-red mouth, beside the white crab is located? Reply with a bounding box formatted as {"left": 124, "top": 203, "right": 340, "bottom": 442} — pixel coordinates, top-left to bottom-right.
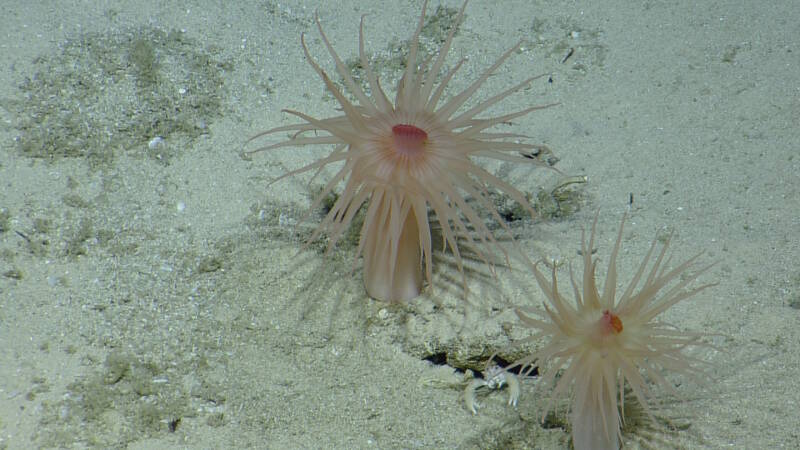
{"left": 507, "top": 217, "right": 713, "bottom": 450}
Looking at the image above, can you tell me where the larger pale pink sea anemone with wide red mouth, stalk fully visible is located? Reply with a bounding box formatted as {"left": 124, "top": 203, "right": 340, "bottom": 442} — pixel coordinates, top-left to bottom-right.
{"left": 245, "top": 3, "right": 550, "bottom": 301}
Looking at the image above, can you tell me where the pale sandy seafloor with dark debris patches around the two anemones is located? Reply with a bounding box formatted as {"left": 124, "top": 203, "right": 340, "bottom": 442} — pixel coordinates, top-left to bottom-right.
{"left": 0, "top": 0, "right": 800, "bottom": 449}
